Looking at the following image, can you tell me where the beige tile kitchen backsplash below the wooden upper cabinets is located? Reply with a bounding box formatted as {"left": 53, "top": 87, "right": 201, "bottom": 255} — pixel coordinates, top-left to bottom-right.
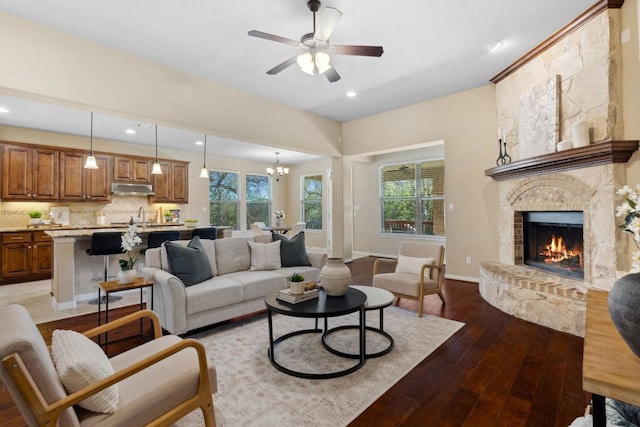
{"left": 0, "top": 195, "right": 180, "bottom": 228}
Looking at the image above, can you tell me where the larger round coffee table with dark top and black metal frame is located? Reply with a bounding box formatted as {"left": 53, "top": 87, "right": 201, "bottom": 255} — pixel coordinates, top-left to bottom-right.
{"left": 264, "top": 288, "right": 367, "bottom": 379}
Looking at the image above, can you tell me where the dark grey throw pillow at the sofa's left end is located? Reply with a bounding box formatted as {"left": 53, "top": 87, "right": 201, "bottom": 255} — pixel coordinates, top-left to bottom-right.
{"left": 163, "top": 236, "right": 213, "bottom": 286}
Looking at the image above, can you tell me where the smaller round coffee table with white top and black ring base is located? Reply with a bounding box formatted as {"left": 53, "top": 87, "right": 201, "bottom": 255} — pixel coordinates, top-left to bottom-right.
{"left": 322, "top": 286, "right": 393, "bottom": 359}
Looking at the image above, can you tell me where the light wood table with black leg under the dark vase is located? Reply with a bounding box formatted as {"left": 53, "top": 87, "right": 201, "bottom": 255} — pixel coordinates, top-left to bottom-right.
{"left": 582, "top": 289, "right": 640, "bottom": 427}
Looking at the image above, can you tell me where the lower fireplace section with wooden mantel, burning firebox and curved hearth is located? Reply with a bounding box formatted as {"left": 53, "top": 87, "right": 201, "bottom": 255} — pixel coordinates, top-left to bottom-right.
{"left": 479, "top": 141, "right": 638, "bottom": 336}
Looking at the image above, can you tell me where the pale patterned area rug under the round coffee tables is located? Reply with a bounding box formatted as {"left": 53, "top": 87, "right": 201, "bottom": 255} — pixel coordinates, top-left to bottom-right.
{"left": 176, "top": 306, "right": 464, "bottom": 427}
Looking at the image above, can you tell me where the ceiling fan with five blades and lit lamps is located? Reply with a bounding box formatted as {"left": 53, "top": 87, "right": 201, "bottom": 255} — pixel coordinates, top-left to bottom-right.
{"left": 249, "top": 0, "right": 384, "bottom": 83}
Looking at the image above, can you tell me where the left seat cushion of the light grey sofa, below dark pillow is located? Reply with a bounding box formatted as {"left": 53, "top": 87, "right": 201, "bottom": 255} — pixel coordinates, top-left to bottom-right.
{"left": 186, "top": 278, "right": 248, "bottom": 314}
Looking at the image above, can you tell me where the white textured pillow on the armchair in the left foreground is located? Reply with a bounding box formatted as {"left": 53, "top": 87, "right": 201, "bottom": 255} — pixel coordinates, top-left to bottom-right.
{"left": 51, "top": 329, "right": 119, "bottom": 413}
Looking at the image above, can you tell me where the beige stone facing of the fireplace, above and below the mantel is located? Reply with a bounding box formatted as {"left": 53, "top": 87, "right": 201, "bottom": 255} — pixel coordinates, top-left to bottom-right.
{"left": 479, "top": 4, "right": 628, "bottom": 336}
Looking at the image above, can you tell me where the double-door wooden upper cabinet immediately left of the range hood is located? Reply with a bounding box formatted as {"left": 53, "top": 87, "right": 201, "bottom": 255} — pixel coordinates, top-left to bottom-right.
{"left": 60, "top": 151, "right": 111, "bottom": 202}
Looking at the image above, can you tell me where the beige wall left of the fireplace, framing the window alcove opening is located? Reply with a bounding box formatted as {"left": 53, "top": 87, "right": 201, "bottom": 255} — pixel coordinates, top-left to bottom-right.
{"left": 342, "top": 86, "right": 498, "bottom": 280}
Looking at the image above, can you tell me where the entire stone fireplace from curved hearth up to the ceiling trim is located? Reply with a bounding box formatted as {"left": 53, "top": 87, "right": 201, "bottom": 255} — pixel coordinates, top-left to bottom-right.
{"left": 479, "top": 1, "right": 638, "bottom": 336}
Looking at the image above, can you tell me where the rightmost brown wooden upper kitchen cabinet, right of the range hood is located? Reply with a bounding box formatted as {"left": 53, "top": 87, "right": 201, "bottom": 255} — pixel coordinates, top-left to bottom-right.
{"left": 149, "top": 161, "right": 189, "bottom": 203}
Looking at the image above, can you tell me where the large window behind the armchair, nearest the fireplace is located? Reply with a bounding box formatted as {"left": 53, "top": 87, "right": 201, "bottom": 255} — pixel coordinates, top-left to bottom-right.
{"left": 380, "top": 159, "right": 445, "bottom": 236}
